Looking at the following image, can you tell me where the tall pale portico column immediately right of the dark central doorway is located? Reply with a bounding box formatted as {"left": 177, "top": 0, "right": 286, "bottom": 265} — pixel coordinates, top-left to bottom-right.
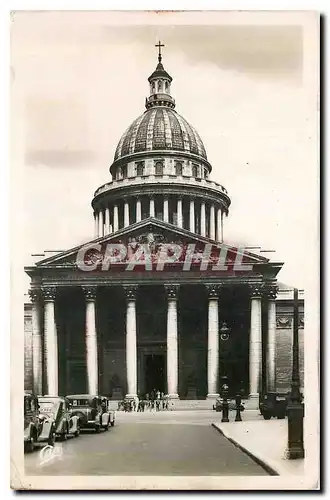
{"left": 165, "top": 285, "right": 179, "bottom": 398}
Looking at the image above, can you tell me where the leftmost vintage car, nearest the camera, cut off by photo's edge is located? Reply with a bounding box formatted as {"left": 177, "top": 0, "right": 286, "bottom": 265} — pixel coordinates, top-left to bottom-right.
{"left": 24, "top": 393, "right": 55, "bottom": 451}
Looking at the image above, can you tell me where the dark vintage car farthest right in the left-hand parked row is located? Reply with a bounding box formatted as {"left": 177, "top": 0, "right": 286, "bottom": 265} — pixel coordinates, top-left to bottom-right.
{"left": 67, "top": 394, "right": 115, "bottom": 432}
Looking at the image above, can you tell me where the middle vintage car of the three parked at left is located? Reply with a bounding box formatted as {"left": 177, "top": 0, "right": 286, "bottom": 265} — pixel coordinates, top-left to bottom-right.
{"left": 38, "top": 396, "right": 80, "bottom": 441}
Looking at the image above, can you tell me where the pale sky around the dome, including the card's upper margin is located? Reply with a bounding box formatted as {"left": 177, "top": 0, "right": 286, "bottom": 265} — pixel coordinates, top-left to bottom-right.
{"left": 11, "top": 11, "right": 318, "bottom": 288}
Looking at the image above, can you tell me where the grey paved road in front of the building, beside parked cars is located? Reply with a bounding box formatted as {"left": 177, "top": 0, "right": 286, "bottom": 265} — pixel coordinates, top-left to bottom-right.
{"left": 25, "top": 411, "right": 267, "bottom": 476}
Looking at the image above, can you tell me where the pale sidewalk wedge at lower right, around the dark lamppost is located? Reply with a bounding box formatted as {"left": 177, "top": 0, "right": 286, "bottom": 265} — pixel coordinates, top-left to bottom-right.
{"left": 212, "top": 415, "right": 304, "bottom": 476}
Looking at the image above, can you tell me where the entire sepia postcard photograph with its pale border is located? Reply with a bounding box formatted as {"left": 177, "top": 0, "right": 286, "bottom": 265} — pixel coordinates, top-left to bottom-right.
{"left": 10, "top": 10, "right": 320, "bottom": 490}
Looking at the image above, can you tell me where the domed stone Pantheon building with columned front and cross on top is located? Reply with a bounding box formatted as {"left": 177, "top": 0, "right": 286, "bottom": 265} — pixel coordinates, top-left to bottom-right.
{"left": 24, "top": 44, "right": 304, "bottom": 401}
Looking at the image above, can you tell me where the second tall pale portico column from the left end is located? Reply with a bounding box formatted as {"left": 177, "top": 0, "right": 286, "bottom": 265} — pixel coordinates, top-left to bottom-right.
{"left": 41, "top": 287, "right": 58, "bottom": 396}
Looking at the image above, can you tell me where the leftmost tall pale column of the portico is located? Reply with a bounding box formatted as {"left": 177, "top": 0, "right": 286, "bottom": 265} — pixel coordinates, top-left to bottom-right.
{"left": 29, "top": 289, "right": 42, "bottom": 394}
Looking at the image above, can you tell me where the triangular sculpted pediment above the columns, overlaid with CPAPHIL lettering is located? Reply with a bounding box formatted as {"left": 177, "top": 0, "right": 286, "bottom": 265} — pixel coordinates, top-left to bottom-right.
{"left": 30, "top": 218, "right": 276, "bottom": 276}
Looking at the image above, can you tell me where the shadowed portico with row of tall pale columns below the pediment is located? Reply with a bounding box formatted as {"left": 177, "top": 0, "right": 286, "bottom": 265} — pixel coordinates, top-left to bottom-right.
{"left": 27, "top": 238, "right": 282, "bottom": 399}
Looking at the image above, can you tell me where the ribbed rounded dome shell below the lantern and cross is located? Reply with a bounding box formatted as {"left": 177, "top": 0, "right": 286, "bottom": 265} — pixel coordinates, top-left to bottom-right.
{"left": 114, "top": 106, "right": 207, "bottom": 161}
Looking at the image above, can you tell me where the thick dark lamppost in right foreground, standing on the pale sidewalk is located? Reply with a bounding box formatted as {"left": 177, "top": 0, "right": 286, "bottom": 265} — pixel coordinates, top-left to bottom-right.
{"left": 287, "top": 288, "right": 305, "bottom": 459}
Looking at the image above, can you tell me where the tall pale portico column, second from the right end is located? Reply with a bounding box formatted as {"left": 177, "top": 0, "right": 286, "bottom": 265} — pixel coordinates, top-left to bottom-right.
{"left": 249, "top": 285, "right": 262, "bottom": 398}
